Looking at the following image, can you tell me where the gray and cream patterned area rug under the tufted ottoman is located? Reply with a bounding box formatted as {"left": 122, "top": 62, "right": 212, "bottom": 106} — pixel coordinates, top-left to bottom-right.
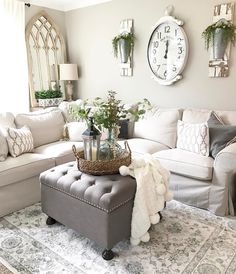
{"left": 0, "top": 201, "right": 236, "bottom": 274}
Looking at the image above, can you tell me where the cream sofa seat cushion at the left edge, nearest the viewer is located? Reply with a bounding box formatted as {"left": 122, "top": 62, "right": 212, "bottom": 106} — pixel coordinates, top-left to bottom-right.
{"left": 0, "top": 153, "right": 55, "bottom": 187}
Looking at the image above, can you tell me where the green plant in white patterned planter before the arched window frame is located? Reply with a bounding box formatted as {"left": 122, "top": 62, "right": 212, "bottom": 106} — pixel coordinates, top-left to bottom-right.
{"left": 35, "top": 89, "right": 63, "bottom": 108}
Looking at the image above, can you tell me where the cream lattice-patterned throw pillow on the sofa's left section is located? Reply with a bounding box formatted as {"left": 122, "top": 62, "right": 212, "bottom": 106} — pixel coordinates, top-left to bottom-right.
{"left": 7, "top": 126, "right": 34, "bottom": 157}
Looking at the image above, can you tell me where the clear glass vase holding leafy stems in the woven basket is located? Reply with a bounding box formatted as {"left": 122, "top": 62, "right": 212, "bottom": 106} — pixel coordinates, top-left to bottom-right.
{"left": 99, "top": 129, "right": 122, "bottom": 160}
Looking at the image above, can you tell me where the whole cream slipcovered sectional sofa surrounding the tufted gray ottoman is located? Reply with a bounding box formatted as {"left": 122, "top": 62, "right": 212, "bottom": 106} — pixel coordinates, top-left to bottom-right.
{"left": 0, "top": 103, "right": 236, "bottom": 216}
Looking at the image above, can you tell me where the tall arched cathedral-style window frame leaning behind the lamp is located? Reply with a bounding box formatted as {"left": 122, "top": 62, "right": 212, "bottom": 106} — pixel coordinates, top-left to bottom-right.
{"left": 25, "top": 11, "right": 66, "bottom": 107}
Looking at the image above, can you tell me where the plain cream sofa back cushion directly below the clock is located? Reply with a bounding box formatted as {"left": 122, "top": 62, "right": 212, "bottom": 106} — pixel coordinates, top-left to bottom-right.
{"left": 134, "top": 109, "right": 180, "bottom": 148}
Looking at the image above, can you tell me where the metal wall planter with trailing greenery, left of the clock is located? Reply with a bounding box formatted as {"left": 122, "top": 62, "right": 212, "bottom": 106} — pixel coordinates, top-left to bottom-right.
{"left": 112, "top": 32, "right": 135, "bottom": 63}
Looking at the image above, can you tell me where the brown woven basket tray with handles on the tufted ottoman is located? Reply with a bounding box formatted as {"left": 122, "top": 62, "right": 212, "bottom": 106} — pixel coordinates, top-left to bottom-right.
{"left": 72, "top": 141, "right": 131, "bottom": 175}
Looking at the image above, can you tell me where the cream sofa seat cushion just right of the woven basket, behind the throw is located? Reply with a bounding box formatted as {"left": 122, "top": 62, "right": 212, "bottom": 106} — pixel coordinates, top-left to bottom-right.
{"left": 118, "top": 138, "right": 169, "bottom": 154}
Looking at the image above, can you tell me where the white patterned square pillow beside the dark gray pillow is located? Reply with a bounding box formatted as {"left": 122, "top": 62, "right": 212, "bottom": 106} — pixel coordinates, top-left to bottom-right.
{"left": 176, "top": 121, "right": 209, "bottom": 156}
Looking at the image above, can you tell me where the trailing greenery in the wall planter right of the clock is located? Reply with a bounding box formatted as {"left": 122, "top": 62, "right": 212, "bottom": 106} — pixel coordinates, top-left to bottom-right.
{"left": 202, "top": 19, "right": 236, "bottom": 50}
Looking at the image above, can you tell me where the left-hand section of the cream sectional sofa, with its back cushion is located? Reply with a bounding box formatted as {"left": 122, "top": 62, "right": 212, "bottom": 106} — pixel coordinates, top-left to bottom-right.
{"left": 0, "top": 108, "right": 82, "bottom": 216}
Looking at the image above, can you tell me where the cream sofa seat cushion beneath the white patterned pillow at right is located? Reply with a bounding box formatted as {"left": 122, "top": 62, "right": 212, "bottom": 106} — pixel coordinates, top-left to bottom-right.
{"left": 153, "top": 148, "right": 214, "bottom": 180}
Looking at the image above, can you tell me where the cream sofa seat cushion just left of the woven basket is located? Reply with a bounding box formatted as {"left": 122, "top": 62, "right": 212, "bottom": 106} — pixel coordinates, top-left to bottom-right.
{"left": 34, "top": 141, "right": 83, "bottom": 165}
